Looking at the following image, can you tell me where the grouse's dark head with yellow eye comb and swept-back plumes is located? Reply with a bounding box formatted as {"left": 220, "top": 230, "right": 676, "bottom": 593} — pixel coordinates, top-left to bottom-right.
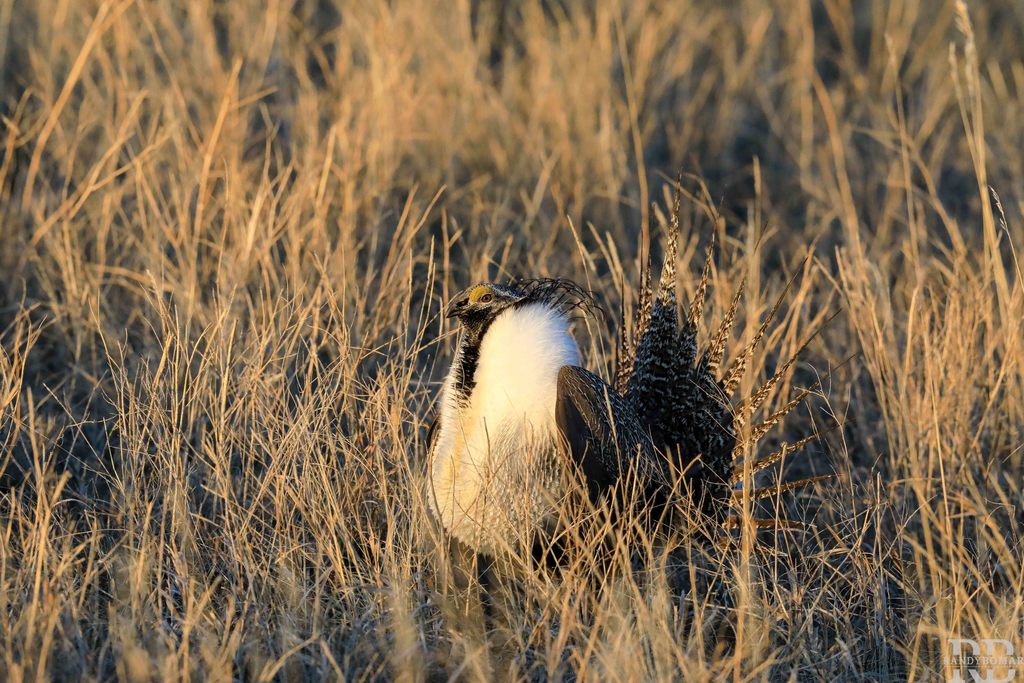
{"left": 444, "top": 278, "right": 595, "bottom": 330}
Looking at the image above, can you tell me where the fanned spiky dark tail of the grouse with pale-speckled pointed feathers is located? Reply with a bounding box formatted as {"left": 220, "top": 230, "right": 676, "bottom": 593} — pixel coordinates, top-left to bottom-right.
{"left": 615, "top": 184, "right": 831, "bottom": 528}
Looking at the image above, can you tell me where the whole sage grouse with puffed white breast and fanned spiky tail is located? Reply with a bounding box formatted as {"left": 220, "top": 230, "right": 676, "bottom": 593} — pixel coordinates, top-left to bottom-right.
{"left": 427, "top": 197, "right": 817, "bottom": 555}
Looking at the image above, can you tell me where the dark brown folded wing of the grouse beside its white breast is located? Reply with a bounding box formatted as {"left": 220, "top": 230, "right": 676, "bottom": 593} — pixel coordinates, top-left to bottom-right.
{"left": 555, "top": 366, "right": 666, "bottom": 500}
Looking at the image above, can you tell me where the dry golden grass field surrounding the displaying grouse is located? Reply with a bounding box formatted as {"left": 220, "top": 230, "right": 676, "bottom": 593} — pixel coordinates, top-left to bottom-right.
{"left": 0, "top": 0, "right": 1024, "bottom": 681}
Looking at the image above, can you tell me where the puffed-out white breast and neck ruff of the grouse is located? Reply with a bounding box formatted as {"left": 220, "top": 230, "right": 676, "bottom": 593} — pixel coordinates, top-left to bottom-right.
{"left": 428, "top": 304, "right": 580, "bottom": 553}
